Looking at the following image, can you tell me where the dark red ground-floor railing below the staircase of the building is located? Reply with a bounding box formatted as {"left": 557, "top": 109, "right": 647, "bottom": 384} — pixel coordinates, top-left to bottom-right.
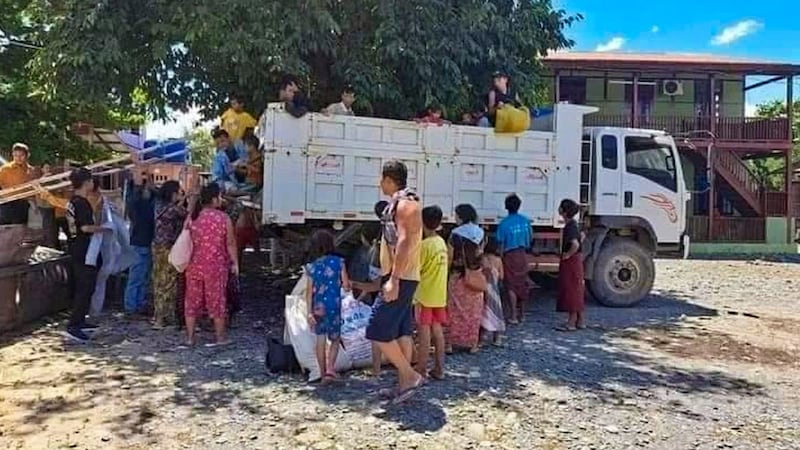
{"left": 686, "top": 216, "right": 767, "bottom": 243}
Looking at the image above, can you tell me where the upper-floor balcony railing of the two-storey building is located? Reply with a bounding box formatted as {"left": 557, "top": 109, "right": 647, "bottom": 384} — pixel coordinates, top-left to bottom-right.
{"left": 584, "top": 114, "right": 789, "bottom": 141}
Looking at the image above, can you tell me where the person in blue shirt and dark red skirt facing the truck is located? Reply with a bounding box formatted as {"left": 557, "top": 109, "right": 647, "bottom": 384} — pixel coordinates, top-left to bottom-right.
{"left": 497, "top": 194, "right": 533, "bottom": 325}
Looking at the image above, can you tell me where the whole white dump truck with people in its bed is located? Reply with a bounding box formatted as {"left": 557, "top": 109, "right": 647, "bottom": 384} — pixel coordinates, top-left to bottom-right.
{"left": 257, "top": 104, "right": 688, "bottom": 306}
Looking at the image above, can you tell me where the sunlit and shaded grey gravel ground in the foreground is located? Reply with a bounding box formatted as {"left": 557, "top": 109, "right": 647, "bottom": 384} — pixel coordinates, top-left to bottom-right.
{"left": 0, "top": 255, "right": 800, "bottom": 450}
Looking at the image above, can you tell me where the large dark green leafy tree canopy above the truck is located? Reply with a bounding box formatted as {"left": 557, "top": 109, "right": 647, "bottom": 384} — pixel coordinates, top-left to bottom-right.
{"left": 27, "top": 0, "right": 579, "bottom": 123}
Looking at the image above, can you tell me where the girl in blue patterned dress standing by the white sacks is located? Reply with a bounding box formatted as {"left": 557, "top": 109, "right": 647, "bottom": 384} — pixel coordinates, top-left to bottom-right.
{"left": 306, "top": 230, "right": 351, "bottom": 384}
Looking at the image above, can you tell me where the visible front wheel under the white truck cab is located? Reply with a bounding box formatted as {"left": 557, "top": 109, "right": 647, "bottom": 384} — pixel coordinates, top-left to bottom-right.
{"left": 589, "top": 238, "right": 656, "bottom": 307}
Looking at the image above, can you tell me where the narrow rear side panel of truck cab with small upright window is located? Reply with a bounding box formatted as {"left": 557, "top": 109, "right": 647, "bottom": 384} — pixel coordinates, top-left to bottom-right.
{"left": 591, "top": 131, "right": 623, "bottom": 216}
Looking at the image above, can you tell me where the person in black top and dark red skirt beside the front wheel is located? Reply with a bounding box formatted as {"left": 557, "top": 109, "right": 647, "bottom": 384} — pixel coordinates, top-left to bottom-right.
{"left": 556, "top": 199, "right": 586, "bottom": 332}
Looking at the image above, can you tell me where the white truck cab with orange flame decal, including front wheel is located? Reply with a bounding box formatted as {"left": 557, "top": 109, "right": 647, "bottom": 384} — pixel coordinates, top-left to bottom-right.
{"left": 581, "top": 127, "right": 689, "bottom": 306}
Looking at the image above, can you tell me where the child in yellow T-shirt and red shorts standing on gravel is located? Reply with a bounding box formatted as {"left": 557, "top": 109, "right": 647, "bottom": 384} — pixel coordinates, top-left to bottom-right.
{"left": 414, "top": 206, "right": 448, "bottom": 380}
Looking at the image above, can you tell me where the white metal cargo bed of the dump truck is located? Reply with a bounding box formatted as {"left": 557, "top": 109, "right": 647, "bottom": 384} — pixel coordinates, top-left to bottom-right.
{"left": 258, "top": 105, "right": 595, "bottom": 226}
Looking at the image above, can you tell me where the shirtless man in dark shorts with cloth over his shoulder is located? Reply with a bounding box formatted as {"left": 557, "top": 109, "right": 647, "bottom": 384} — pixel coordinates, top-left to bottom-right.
{"left": 366, "top": 161, "right": 425, "bottom": 403}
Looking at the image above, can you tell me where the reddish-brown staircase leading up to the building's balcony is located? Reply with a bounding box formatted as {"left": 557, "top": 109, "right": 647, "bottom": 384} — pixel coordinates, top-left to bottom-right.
{"left": 696, "top": 147, "right": 765, "bottom": 216}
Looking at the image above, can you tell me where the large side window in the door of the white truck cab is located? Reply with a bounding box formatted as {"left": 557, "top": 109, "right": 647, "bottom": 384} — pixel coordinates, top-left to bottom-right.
{"left": 625, "top": 136, "right": 678, "bottom": 192}
